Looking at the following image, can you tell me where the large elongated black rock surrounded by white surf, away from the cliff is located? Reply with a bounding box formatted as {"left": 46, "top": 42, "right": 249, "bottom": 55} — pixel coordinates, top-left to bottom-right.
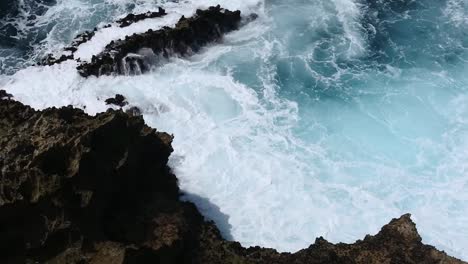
{"left": 77, "top": 6, "right": 241, "bottom": 77}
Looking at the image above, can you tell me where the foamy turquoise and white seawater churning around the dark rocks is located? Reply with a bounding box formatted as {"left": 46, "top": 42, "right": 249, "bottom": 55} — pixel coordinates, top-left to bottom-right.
{"left": 0, "top": 0, "right": 468, "bottom": 260}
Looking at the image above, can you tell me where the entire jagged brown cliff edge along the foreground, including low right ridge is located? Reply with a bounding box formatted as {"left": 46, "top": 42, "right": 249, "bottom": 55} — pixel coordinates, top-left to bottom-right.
{"left": 0, "top": 99, "right": 464, "bottom": 264}
